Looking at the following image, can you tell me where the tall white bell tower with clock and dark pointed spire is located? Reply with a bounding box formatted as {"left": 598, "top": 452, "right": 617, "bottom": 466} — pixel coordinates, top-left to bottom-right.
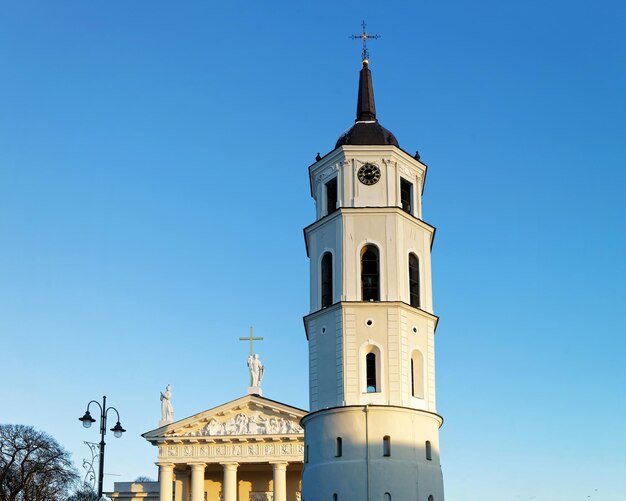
{"left": 302, "top": 55, "right": 444, "bottom": 501}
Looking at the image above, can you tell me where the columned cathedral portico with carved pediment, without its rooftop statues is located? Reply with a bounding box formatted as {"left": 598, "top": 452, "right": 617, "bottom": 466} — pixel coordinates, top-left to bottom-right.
{"left": 143, "top": 395, "right": 306, "bottom": 501}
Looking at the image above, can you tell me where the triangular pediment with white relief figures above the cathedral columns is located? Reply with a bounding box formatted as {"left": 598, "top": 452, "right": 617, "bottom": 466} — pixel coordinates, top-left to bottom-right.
{"left": 142, "top": 395, "right": 307, "bottom": 443}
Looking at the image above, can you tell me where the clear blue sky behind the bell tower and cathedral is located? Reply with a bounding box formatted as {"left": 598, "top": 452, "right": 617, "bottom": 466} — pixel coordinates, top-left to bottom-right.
{"left": 0, "top": 0, "right": 626, "bottom": 501}
